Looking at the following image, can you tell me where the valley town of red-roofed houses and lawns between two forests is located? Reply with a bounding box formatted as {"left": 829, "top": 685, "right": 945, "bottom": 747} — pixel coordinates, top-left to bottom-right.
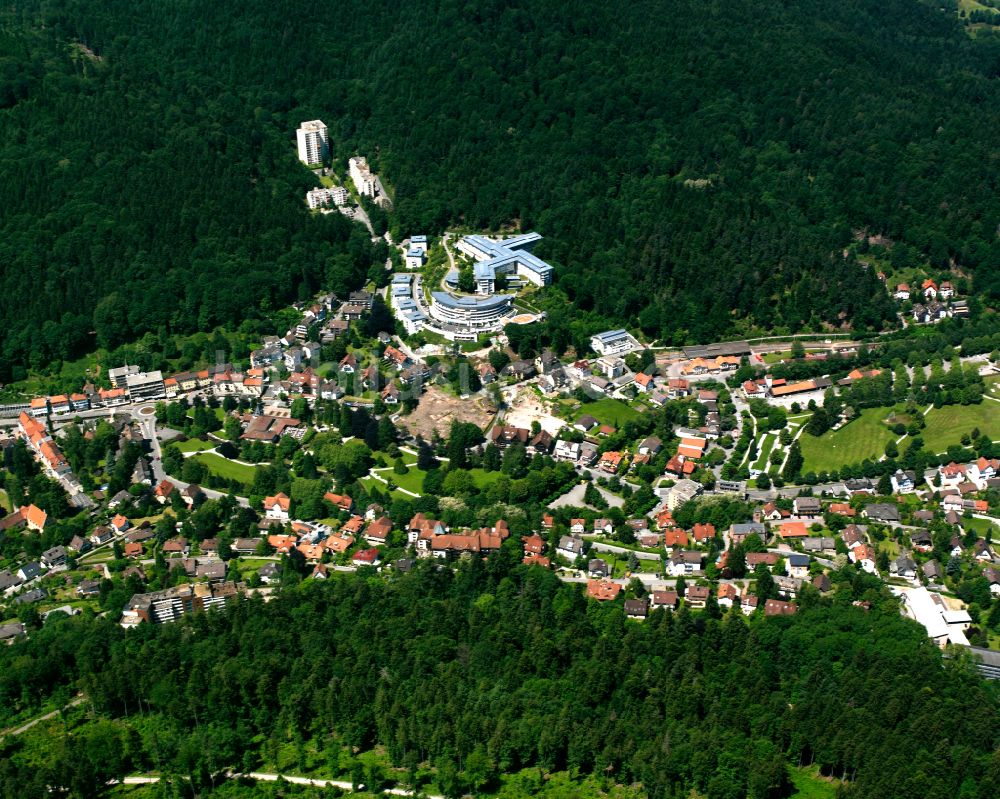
{"left": 0, "top": 133, "right": 1000, "bottom": 670}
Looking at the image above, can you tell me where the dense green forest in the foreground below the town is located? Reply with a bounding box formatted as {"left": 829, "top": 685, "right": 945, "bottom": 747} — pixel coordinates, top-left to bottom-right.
{"left": 0, "top": 564, "right": 1000, "bottom": 799}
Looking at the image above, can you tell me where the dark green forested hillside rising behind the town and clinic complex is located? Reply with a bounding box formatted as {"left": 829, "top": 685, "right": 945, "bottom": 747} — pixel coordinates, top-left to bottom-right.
{"left": 0, "top": 0, "right": 1000, "bottom": 380}
